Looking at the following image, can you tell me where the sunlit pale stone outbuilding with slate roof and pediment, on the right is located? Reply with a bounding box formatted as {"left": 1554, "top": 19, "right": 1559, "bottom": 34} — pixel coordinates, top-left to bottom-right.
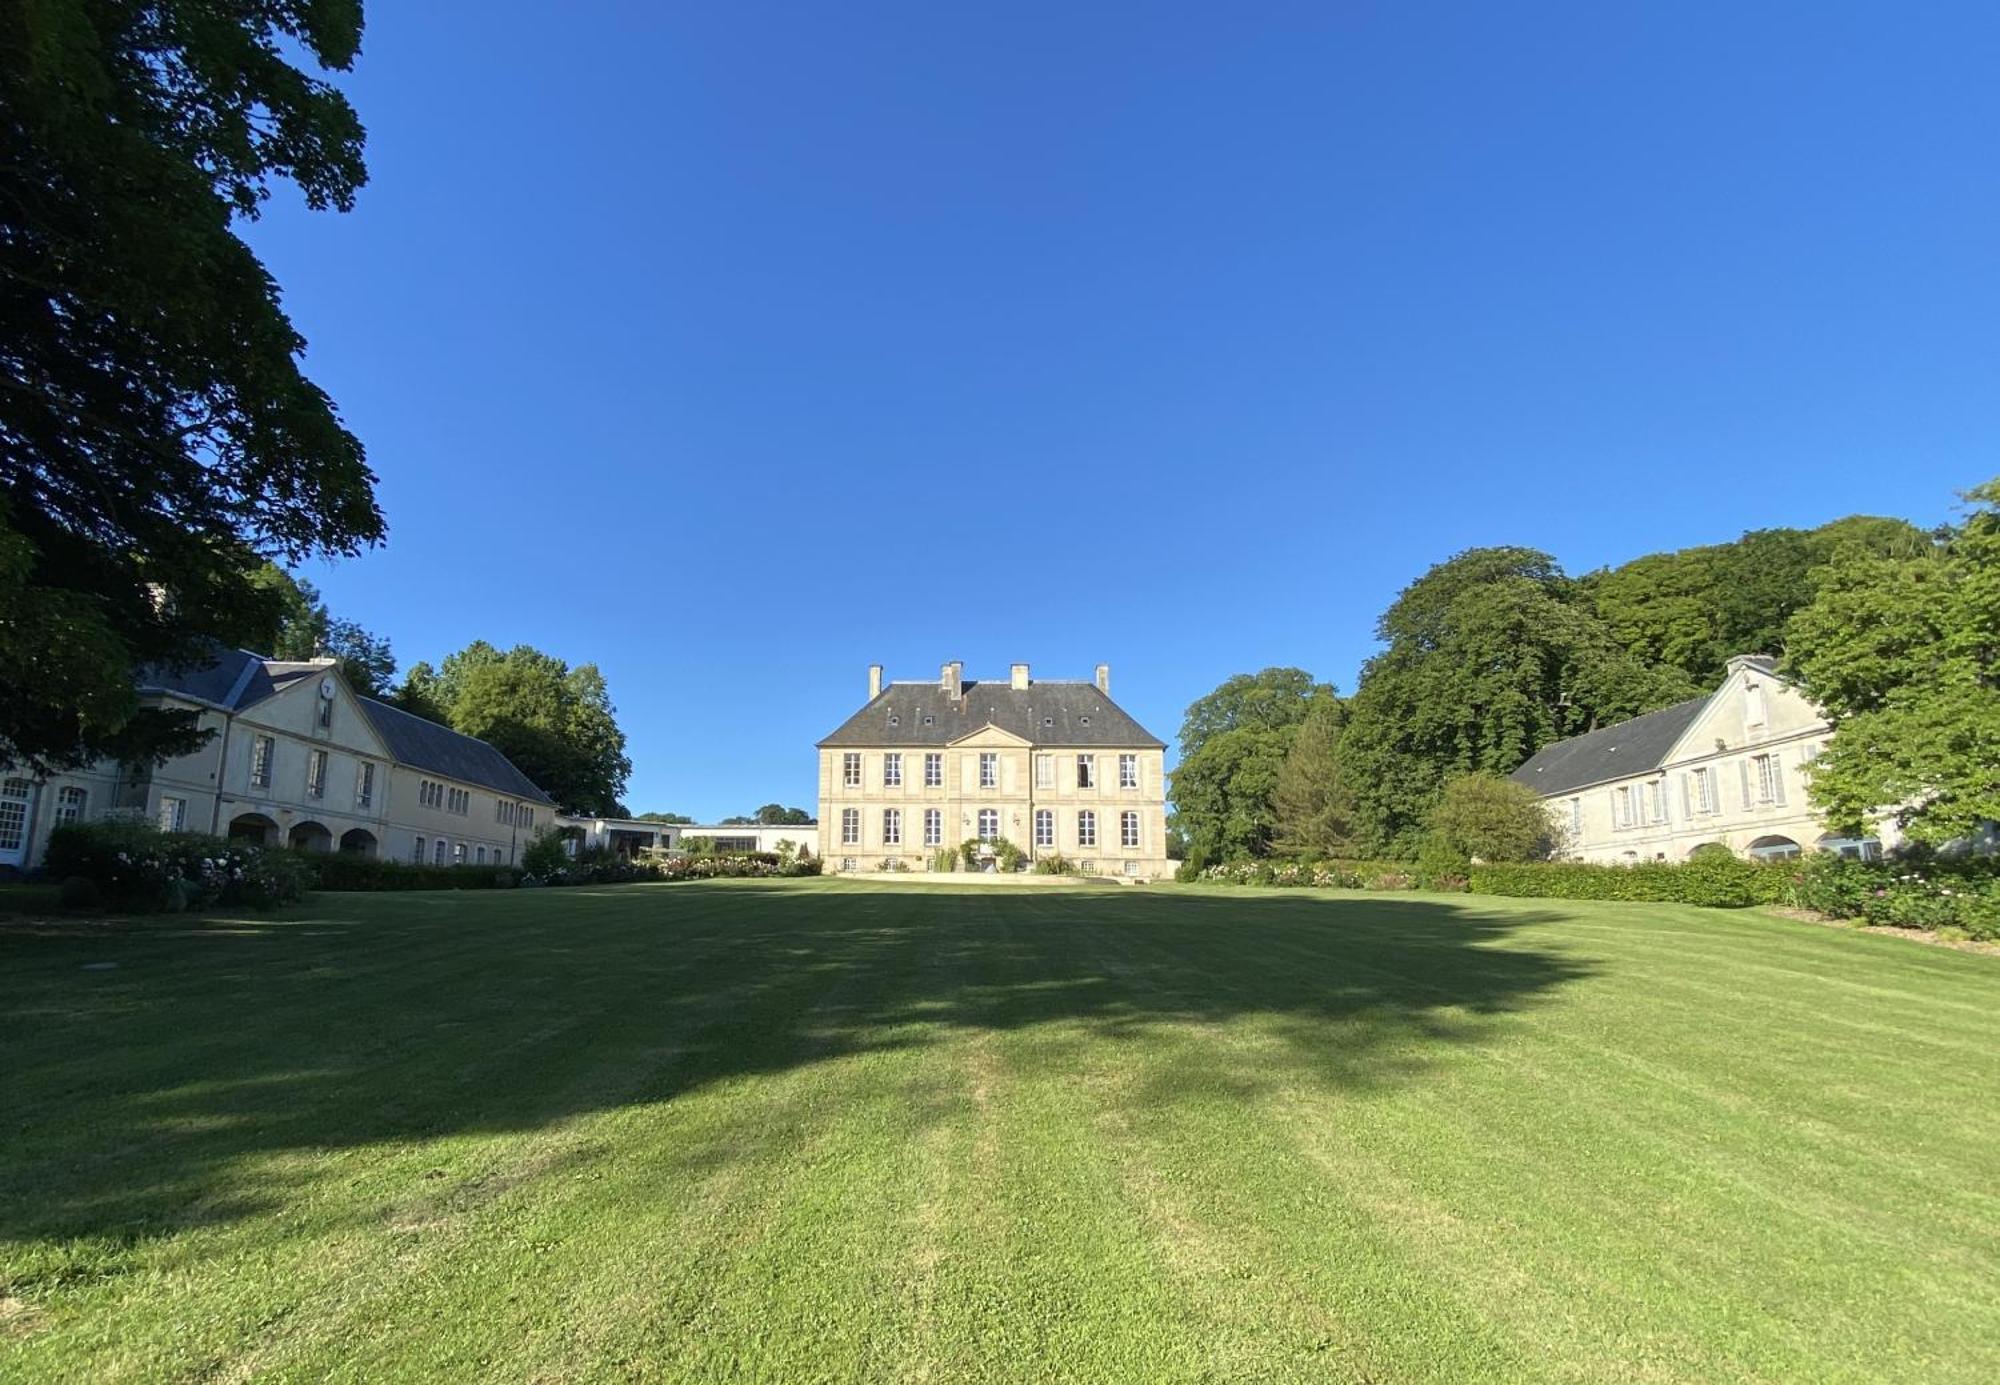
{"left": 1512, "top": 654, "right": 1894, "bottom": 863}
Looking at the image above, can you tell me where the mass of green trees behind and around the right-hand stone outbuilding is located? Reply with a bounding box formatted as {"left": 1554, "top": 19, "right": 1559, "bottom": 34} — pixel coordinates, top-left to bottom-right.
{"left": 1172, "top": 492, "right": 2000, "bottom": 867}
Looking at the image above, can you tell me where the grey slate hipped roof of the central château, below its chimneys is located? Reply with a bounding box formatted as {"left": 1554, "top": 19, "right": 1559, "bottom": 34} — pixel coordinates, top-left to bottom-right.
{"left": 820, "top": 678, "right": 1166, "bottom": 751}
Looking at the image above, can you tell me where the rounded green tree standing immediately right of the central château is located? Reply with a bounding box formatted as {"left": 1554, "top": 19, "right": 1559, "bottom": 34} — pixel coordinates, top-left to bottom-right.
{"left": 1172, "top": 668, "right": 1332, "bottom": 863}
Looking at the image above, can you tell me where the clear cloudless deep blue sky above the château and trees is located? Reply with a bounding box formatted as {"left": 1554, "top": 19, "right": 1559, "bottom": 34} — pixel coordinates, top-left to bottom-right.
{"left": 250, "top": 0, "right": 2000, "bottom": 819}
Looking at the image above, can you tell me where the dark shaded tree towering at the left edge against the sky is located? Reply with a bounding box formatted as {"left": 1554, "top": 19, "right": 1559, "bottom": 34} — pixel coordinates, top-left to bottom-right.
{"left": 0, "top": 0, "right": 382, "bottom": 767}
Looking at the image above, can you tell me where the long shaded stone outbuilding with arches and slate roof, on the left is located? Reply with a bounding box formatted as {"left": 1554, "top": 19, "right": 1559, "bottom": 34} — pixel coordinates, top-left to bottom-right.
{"left": 0, "top": 648, "right": 556, "bottom": 869}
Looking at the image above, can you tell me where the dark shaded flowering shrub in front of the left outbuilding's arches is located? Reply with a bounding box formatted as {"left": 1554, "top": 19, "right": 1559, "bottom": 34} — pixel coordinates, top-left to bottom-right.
{"left": 44, "top": 819, "right": 312, "bottom": 913}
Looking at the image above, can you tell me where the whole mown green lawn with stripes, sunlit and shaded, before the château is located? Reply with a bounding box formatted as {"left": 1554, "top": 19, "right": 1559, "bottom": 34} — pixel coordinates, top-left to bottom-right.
{"left": 0, "top": 881, "right": 2000, "bottom": 1385}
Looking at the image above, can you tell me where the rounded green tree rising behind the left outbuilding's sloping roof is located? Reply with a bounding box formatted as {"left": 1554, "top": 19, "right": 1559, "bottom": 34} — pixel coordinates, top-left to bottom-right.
{"left": 396, "top": 640, "right": 632, "bottom": 817}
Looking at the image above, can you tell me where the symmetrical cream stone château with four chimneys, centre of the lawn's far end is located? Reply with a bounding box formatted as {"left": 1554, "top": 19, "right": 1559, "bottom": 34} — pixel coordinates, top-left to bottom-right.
{"left": 818, "top": 660, "right": 1174, "bottom": 881}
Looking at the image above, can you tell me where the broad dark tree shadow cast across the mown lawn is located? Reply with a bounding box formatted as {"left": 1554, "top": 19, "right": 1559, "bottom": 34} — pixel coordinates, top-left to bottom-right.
{"left": 0, "top": 883, "right": 1592, "bottom": 1256}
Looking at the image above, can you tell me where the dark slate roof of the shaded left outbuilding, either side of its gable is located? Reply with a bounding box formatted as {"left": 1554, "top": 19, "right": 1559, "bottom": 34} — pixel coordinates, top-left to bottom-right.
{"left": 138, "top": 646, "right": 554, "bottom": 803}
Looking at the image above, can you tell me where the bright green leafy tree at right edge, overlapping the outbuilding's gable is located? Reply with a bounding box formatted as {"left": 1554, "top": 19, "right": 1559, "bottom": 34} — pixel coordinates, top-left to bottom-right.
{"left": 1788, "top": 478, "right": 2000, "bottom": 845}
